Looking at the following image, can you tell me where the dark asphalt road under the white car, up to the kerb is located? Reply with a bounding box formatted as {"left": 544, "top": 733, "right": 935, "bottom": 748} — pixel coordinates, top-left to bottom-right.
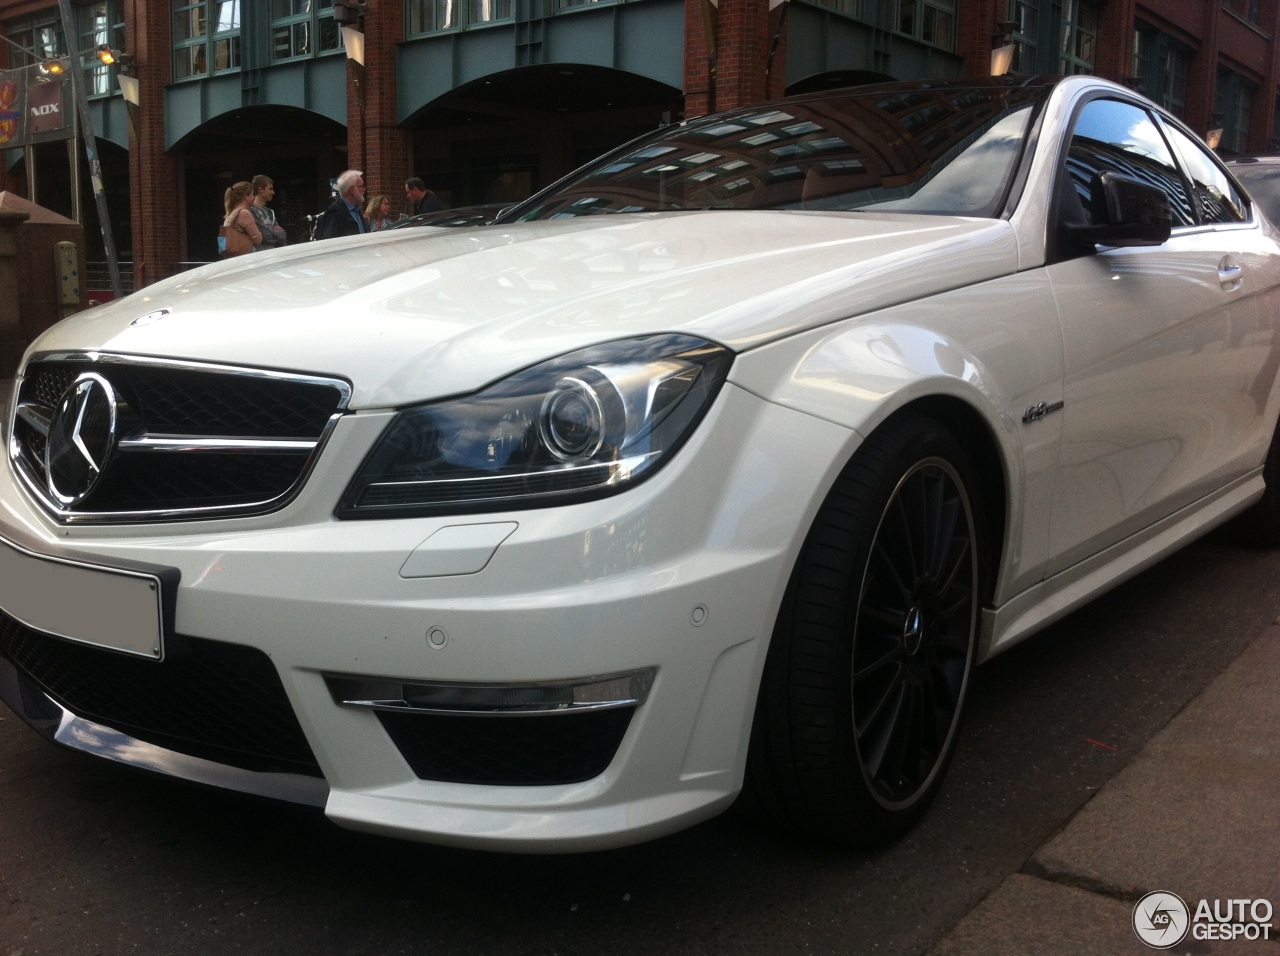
{"left": 0, "top": 524, "right": 1280, "bottom": 956}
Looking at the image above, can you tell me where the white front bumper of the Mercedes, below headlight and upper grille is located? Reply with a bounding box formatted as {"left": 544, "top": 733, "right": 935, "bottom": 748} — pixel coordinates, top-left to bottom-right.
{"left": 0, "top": 386, "right": 855, "bottom": 851}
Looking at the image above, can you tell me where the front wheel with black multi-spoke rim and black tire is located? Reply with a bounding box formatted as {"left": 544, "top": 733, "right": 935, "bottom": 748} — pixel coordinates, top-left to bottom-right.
{"left": 746, "top": 413, "right": 986, "bottom": 846}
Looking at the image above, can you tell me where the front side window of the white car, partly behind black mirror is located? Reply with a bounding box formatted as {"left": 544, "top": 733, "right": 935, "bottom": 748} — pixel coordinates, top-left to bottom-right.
{"left": 1059, "top": 100, "right": 1197, "bottom": 228}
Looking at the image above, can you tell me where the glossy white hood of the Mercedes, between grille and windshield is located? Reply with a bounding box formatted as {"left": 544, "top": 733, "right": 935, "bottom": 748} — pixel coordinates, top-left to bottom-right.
{"left": 31, "top": 211, "right": 1016, "bottom": 408}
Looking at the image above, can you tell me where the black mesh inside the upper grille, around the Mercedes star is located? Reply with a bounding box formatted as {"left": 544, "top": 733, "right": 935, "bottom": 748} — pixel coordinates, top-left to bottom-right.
{"left": 14, "top": 361, "right": 344, "bottom": 520}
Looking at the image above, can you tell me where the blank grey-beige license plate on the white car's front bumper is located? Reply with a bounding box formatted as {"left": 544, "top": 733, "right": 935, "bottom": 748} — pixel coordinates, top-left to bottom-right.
{"left": 0, "top": 539, "right": 164, "bottom": 660}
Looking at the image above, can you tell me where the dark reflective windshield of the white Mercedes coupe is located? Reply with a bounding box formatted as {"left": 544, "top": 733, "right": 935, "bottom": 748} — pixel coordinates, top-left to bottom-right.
{"left": 515, "top": 84, "right": 1047, "bottom": 220}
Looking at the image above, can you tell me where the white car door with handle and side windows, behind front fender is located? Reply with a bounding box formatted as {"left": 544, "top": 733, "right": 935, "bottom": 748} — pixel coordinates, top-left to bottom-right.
{"left": 1047, "top": 99, "right": 1276, "bottom": 573}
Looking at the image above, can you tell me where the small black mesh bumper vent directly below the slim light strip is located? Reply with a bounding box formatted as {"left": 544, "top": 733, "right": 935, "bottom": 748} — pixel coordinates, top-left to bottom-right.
{"left": 378, "top": 708, "right": 635, "bottom": 786}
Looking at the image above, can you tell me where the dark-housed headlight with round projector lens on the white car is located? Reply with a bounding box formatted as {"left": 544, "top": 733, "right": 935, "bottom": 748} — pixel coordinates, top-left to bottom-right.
{"left": 337, "top": 334, "right": 731, "bottom": 518}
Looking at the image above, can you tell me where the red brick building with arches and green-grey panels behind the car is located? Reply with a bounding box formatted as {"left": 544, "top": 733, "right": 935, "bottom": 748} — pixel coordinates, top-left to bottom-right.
{"left": 0, "top": 0, "right": 1280, "bottom": 293}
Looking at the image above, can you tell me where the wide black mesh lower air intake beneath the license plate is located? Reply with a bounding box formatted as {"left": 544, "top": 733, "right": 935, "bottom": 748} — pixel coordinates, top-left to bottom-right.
{"left": 0, "top": 612, "right": 323, "bottom": 777}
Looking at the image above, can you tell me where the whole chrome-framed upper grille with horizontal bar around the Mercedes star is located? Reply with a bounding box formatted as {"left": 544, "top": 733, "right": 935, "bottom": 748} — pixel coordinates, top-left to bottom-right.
{"left": 10, "top": 356, "right": 351, "bottom": 522}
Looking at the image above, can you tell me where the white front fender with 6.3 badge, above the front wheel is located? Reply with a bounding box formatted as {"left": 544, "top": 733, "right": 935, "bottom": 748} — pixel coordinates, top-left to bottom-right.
{"left": 731, "top": 270, "right": 1062, "bottom": 603}
